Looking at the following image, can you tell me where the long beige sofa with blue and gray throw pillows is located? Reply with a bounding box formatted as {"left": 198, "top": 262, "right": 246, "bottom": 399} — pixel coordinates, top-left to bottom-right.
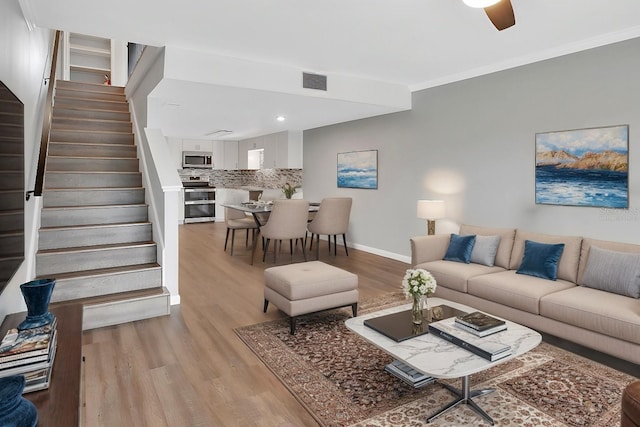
{"left": 411, "top": 225, "right": 640, "bottom": 364}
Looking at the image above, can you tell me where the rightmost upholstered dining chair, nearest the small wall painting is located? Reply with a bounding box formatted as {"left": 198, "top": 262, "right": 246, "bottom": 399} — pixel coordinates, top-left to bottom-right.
{"left": 307, "top": 197, "right": 352, "bottom": 259}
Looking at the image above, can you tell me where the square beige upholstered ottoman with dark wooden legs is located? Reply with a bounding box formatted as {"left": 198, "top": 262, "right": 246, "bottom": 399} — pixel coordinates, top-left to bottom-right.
{"left": 264, "top": 261, "right": 358, "bottom": 334}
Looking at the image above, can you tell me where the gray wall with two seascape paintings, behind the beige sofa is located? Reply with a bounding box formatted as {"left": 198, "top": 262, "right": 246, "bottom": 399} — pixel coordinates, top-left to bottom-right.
{"left": 303, "top": 39, "right": 640, "bottom": 260}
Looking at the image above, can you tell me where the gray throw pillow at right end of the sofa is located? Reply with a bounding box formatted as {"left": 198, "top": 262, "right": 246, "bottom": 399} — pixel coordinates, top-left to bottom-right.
{"left": 582, "top": 246, "right": 640, "bottom": 298}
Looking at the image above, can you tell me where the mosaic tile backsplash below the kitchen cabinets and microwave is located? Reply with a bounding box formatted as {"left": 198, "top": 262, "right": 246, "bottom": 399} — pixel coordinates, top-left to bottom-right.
{"left": 178, "top": 169, "right": 302, "bottom": 188}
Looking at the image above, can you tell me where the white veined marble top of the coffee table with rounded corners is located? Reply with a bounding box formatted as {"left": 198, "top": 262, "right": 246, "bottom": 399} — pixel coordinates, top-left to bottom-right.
{"left": 345, "top": 298, "right": 542, "bottom": 378}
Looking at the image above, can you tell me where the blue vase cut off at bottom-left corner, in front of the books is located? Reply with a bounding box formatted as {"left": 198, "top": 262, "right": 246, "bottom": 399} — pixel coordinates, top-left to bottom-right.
{"left": 0, "top": 375, "right": 38, "bottom": 427}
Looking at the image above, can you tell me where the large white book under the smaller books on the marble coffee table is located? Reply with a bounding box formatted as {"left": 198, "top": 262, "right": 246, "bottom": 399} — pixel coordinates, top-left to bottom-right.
{"left": 429, "top": 318, "right": 511, "bottom": 362}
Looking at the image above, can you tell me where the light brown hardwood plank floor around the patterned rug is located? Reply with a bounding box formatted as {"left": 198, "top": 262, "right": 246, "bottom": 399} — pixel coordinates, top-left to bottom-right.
{"left": 81, "top": 222, "right": 408, "bottom": 427}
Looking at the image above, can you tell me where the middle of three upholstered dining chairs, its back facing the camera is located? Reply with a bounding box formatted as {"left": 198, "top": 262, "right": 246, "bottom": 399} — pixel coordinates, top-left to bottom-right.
{"left": 260, "top": 199, "right": 309, "bottom": 263}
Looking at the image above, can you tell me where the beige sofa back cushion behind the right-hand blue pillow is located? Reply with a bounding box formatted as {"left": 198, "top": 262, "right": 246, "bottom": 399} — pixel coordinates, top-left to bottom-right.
{"left": 509, "top": 230, "right": 582, "bottom": 283}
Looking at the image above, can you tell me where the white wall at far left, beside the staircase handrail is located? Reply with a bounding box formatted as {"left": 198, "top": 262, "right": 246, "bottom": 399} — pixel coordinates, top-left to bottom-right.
{"left": 0, "top": 0, "right": 52, "bottom": 319}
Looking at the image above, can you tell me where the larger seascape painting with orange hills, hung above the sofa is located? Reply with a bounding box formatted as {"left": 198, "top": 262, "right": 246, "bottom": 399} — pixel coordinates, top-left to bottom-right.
{"left": 536, "top": 125, "right": 629, "bottom": 209}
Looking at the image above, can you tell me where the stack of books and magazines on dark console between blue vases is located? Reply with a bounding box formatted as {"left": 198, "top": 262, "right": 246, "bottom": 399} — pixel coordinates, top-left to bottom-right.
{"left": 0, "top": 318, "right": 57, "bottom": 393}
